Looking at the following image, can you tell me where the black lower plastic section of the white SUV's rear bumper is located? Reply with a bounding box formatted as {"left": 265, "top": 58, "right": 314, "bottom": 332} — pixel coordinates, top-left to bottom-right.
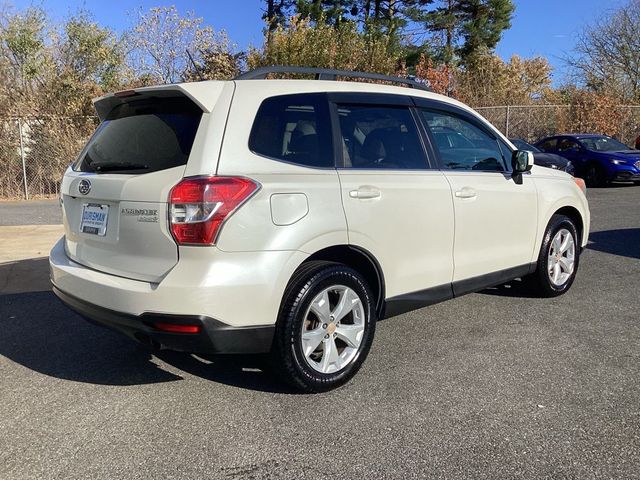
{"left": 53, "top": 286, "right": 275, "bottom": 354}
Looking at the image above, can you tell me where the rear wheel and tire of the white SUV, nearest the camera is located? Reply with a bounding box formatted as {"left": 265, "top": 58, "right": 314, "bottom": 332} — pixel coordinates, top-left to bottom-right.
{"left": 271, "top": 261, "right": 377, "bottom": 393}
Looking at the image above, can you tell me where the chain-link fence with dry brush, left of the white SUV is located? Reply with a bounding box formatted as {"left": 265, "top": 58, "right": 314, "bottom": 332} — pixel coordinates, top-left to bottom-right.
{"left": 0, "top": 116, "right": 97, "bottom": 199}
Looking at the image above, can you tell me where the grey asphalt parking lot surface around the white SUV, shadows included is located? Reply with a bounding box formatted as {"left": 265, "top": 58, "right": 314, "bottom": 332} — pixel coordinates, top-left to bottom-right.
{"left": 0, "top": 186, "right": 640, "bottom": 479}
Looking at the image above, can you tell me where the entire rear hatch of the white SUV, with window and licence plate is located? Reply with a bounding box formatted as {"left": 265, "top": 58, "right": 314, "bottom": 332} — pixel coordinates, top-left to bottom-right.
{"left": 62, "top": 89, "right": 203, "bottom": 282}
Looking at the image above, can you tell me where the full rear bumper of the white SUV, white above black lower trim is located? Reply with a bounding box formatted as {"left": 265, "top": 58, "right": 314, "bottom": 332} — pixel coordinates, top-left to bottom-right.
{"left": 49, "top": 238, "right": 306, "bottom": 353}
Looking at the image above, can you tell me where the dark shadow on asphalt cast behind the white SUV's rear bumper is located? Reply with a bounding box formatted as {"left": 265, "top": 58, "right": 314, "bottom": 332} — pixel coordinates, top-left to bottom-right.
{"left": 0, "top": 258, "right": 293, "bottom": 393}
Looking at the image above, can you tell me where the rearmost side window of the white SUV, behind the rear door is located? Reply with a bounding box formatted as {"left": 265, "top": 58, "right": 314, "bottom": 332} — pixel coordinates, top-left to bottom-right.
{"left": 249, "top": 95, "right": 334, "bottom": 167}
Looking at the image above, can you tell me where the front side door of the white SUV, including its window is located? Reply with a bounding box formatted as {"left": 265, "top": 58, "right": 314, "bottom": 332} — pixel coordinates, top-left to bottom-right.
{"left": 417, "top": 100, "right": 537, "bottom": 294}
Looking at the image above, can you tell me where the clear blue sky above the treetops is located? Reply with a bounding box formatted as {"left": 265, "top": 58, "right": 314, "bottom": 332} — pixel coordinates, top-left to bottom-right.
{"left": 5, "top": 0, "right": 624, "bottom": 83}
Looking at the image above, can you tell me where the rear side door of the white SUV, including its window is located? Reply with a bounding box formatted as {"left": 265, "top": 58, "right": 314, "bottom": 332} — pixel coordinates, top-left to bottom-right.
{"left": 329, "top": 93, "right": 454, "bottom": 304}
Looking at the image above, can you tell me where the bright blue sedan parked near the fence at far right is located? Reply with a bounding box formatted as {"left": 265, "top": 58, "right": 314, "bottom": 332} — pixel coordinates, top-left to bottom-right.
{"left": 535, "top": 134, "right": 640, "bottom": 187}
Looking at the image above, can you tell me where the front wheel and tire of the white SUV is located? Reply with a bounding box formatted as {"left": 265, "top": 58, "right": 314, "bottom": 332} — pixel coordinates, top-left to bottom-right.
{"left": 524, "top": 215, "right": 581, "bottom": 297}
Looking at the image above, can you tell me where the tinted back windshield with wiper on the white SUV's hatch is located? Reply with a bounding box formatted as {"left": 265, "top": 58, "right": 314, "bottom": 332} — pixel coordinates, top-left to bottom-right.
{"left": 74, "top": 97, "right": 202, "bottom": 174}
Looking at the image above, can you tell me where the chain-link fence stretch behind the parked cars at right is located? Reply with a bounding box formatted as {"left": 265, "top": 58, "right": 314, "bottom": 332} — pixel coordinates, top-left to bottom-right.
{"left": 476, "top": 105, "right": 640, "bottom": 146}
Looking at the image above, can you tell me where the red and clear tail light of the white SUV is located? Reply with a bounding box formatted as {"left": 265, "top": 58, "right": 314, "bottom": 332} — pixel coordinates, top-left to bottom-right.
{"left": 169, "top": 177, "right": 260, "bottom": 245}
